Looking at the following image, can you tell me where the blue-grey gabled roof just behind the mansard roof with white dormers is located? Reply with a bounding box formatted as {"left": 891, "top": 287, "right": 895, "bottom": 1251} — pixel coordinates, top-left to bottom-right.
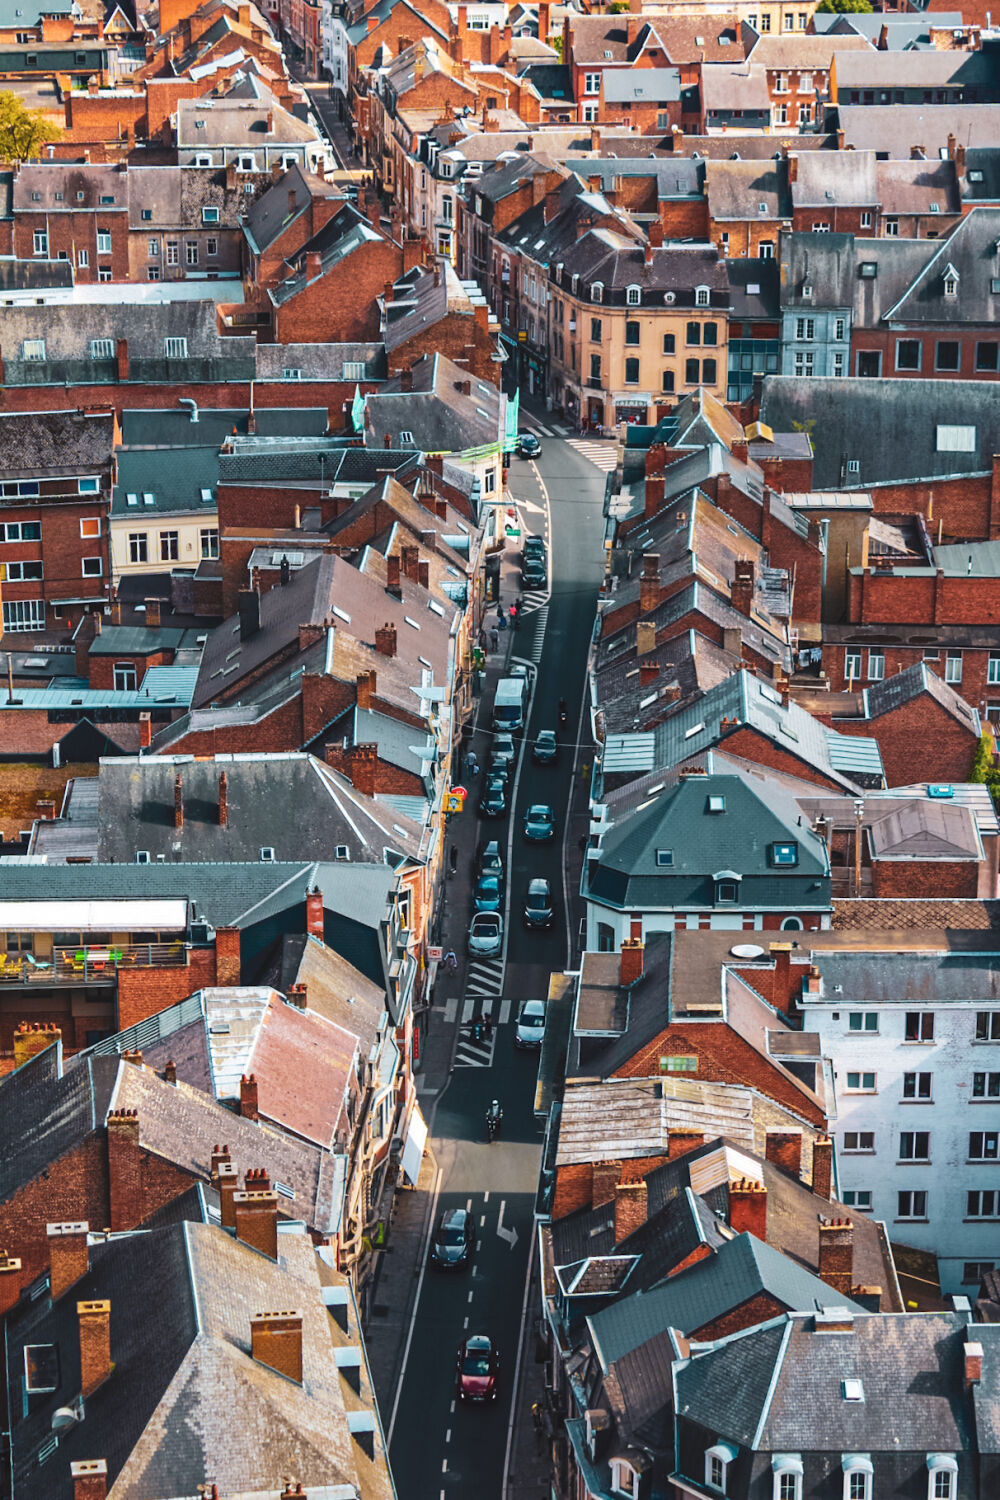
{"left": 588, "top": 1235, "right": 864, "bottom": 1365}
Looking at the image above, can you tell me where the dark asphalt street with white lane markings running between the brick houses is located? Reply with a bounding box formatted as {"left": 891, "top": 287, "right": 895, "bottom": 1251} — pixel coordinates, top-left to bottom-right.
{"left": 391, "top": 438, "right": 604, "bottom": 1500}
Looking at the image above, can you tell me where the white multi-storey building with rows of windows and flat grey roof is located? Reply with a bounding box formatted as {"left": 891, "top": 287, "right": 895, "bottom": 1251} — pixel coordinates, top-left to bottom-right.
{"left": 802, "top": 950, "right": 1000, "bottom": 1295}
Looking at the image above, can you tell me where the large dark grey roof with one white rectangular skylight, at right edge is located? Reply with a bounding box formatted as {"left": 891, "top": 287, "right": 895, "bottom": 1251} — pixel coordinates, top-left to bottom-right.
{"left": 760, "top": 375, "right": 1000, "bottom": 489}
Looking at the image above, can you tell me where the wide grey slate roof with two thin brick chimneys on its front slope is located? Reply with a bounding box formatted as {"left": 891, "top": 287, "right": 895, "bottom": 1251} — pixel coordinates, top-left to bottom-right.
{"left": 99, "top": 755, "right": 423, "bottom": 864}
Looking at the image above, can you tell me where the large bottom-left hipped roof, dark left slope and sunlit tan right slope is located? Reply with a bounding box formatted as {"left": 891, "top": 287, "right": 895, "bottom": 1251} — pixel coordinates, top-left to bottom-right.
{"left": 6, "top": 1221, "right": 385, "bottom": 1500}
